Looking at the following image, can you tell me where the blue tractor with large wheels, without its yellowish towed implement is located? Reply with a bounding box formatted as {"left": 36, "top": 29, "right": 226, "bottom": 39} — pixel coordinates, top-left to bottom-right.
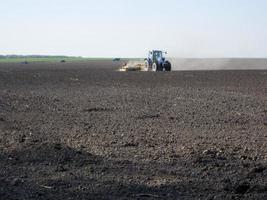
{"left": 144, "top": 50, "right": 171, "bottom": 72}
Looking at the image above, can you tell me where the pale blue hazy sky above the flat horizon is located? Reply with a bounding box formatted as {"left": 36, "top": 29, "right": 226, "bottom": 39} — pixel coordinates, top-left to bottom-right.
{"left": 0, "top": 0, "right": 267, "bottom": 57}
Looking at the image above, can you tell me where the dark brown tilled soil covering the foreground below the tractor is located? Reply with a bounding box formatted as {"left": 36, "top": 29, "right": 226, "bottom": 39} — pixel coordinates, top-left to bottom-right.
{"left": 0, "top": 61, "right": 267, "bottom": 200}
